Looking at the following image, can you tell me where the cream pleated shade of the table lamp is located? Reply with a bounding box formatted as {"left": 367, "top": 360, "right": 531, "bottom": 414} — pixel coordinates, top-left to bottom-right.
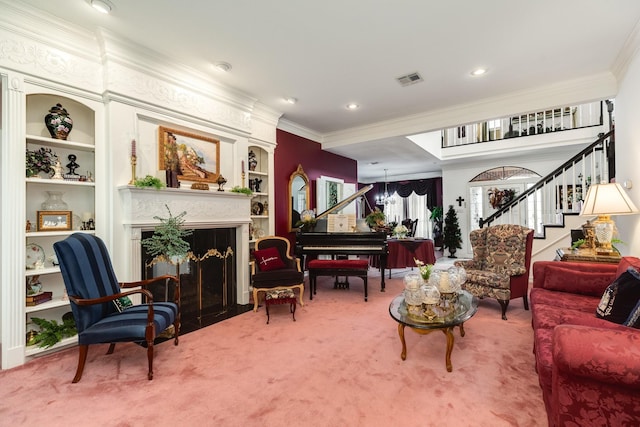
{"left": 580, "top": 182, "right": 638, "bottom": 216}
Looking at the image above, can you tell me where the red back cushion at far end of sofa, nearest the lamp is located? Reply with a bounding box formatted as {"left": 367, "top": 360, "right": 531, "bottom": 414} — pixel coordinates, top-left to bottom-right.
{"left": 543, "top": 263, "right": 611, "bottom": 297}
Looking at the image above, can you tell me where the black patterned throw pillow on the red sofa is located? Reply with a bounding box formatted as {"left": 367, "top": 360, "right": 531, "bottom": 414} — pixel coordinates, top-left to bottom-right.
{"left": 596, "top": 267, "right": 640, "bottom": 324}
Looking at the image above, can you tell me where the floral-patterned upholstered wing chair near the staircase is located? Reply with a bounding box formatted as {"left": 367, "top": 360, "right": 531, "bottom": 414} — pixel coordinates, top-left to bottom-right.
{"left": 455, "top": 224, "right": 533, "bottom": 320}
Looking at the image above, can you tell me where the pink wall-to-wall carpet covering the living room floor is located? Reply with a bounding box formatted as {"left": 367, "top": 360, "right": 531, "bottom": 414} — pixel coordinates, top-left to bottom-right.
{"left": 0, "top": 270, "right": 546, "bottom": 427}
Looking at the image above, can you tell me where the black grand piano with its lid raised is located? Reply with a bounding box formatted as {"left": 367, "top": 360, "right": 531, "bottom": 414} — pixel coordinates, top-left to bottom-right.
{"left": 295, "top": 185, "right": 389, "bottom": 292}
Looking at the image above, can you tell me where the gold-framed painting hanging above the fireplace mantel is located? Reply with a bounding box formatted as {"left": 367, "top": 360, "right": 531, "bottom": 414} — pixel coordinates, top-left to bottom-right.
{"left": 158, "top": 126, "right": 220, "bottom": 183}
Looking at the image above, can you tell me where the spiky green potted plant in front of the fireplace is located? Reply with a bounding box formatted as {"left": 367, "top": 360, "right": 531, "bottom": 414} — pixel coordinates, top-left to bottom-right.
{"left": 141, "top": 205, "right": 193, "bottom": 262}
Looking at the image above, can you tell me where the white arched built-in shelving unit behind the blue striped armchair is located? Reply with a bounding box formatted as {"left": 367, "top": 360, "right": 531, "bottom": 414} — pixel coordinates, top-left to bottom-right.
{"left": 23, "top": 93, "right": 96, "bottom": 358}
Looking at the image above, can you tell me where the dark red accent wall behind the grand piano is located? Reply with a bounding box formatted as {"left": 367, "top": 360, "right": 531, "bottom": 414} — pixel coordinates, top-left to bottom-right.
{"left": 273, "top": 129, "right": 358, "bottom": 242}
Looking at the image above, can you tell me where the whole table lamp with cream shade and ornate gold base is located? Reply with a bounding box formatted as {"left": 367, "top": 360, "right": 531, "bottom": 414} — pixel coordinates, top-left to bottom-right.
{"left": 580, "top": 183, "right": 638, "bottom": 255}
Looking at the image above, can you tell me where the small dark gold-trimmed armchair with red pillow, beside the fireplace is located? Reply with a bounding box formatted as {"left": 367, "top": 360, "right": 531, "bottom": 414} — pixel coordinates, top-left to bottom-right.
{"left": 251, "top": 236, "right": 304, "bottom": 311}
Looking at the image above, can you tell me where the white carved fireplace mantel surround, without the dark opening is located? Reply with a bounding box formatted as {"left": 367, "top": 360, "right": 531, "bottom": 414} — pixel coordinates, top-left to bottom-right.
{"left": 118, "top": 185, "right": 251, "bottom": 304}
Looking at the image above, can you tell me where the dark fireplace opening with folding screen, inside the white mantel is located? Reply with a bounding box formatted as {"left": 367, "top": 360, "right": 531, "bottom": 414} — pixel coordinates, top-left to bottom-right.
{"left": 142, "top": 228, "right": 237, "bottom": 332}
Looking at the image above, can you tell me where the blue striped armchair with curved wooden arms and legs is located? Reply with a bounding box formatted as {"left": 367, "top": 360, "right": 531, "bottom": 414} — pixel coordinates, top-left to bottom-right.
{"left": 53, "top": 233, "right": 180, "bottom": 383}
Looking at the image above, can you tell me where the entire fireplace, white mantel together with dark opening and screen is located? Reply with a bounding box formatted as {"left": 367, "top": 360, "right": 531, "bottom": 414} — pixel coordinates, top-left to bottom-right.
{"left": 118, "top": 186, "right": 251, "bottom": 331}
